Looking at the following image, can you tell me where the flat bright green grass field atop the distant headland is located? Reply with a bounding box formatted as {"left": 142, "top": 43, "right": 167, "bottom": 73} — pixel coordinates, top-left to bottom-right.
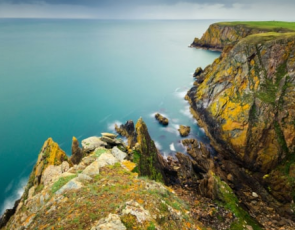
{"left": 217, "top": 21, "right": 295, "bottom": 31}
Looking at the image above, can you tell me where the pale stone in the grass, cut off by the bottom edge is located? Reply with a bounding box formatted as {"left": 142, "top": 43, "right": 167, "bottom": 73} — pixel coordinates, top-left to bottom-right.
{"left": 91, "top": 213, "right": 126, "bottom": 230}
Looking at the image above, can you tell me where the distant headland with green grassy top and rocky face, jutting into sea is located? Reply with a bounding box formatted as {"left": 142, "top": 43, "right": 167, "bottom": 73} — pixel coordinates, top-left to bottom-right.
{"left": 191, "top": 21, "right": 295, "bottom": 51}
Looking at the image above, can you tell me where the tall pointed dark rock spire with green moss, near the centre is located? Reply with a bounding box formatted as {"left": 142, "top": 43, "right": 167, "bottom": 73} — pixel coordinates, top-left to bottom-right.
{"left": 136, "top": 118, "right": 165, "bottom": 182}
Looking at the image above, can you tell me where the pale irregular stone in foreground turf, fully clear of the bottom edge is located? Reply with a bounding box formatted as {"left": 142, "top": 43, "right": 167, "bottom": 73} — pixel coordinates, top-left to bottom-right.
{"left": 122, "top": 200, "right": 152, "bottom": 223}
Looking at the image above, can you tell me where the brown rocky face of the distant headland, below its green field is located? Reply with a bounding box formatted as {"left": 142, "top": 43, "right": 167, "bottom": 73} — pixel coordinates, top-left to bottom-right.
{"left": 191, "top": 23, "right": 290, "bottom": 51}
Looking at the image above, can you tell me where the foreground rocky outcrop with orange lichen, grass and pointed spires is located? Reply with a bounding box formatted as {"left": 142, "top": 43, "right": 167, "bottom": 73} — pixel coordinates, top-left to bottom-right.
{"left": 1, "top": 119, "right": 206, "bottom": 230}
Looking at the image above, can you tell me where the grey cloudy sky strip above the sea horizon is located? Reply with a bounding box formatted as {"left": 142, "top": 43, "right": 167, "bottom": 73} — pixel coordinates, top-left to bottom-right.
{"left": 0, "top": 0, "right": 295, "bottom": 21}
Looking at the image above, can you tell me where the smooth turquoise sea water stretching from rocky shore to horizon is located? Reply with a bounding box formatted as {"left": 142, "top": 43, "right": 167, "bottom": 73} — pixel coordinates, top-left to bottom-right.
{"left": 0, "top": 19, "right": 219, "bottom": 213}
